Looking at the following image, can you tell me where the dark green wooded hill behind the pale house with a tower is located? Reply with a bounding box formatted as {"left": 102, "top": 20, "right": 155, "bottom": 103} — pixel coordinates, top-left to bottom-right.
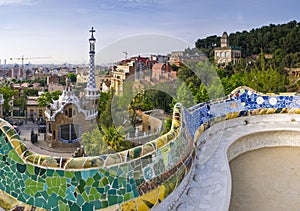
{"left": 195, "top": 20, "right": 300, "bottom": 66}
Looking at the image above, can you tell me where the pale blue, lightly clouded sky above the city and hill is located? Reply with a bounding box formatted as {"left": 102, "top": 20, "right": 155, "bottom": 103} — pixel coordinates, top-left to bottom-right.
{"left": 0, "top": 0, "right": 300, "bottom": 64}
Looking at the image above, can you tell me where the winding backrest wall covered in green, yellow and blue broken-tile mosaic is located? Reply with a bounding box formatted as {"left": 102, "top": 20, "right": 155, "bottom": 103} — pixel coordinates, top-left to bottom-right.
{"left": 0, "top": 87, "right": 300, "bottom": 211}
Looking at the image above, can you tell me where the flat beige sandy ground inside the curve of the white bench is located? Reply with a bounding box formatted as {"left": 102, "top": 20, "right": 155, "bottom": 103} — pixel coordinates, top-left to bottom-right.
{"left": 230, "top": 147, "right": 300, "bottom": 211}
